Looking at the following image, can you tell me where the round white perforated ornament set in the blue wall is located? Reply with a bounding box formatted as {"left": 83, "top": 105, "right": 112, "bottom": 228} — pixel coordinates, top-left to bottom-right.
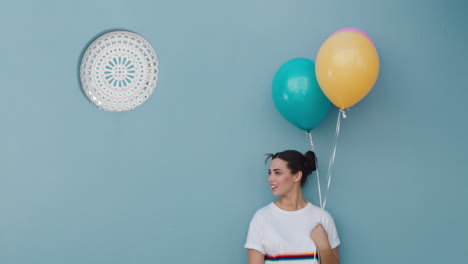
{"left": 80, "top": 31, "right": 159, "bottom": 112}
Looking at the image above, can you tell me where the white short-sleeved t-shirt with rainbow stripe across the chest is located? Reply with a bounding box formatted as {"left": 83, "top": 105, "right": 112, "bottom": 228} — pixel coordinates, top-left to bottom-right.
{"left": 244, "top": 202, "right": 340, "bottom": 264}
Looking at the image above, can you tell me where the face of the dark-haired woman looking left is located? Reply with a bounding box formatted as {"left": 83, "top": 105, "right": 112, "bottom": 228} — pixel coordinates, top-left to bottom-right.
{"left": 268, "top": 158, "right": 301, "bottom": 196}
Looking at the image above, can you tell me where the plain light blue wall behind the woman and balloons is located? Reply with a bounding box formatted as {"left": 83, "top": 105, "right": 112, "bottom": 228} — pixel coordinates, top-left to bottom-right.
{"left": 0, "top": 0, "right": 468, "bottom": 264}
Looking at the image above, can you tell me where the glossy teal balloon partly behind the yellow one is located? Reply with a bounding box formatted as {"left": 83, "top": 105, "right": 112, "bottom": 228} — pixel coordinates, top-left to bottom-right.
{"left": 272, "top": 58, "right": 330, "bottom": 131}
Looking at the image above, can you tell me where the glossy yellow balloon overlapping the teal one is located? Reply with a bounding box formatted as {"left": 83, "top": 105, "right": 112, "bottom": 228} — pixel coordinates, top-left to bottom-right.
{"left": 315, "top": 31, "right": 379, "bottom": 108}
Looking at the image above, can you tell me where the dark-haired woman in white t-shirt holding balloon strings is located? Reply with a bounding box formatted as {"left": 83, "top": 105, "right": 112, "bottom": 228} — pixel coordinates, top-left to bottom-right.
{"left": 245, "top": 150, "right": 340, "bottom": 264}
